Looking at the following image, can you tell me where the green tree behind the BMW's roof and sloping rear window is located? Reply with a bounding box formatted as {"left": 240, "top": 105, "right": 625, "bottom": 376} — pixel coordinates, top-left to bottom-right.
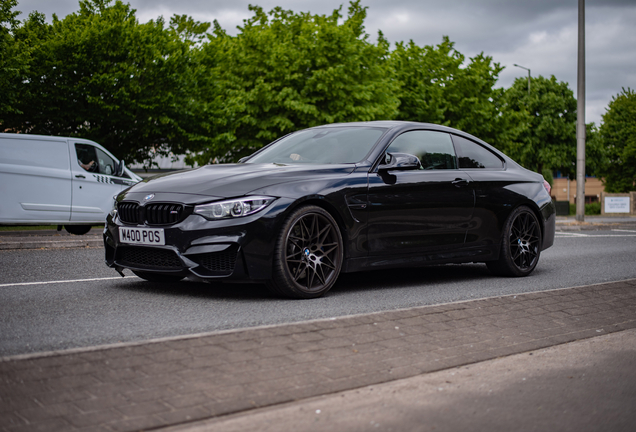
{"left": 391, "top": 36, "right": 508, "bottom": 145}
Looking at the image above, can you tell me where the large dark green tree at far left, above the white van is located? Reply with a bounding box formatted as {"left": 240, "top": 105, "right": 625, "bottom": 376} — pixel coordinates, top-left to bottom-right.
{"left": 3, "top": 0, "right": 216, "bottom": 165}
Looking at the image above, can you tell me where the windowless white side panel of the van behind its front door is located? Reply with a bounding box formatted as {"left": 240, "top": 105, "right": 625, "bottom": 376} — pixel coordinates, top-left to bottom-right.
{"left": 0, "top": 134, "right": 71, "bottom": 224}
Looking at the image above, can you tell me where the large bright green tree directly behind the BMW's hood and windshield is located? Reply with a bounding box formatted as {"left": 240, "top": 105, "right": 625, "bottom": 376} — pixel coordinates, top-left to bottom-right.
{"left": 198, "top": 1, "right": 398, "bottom": 163}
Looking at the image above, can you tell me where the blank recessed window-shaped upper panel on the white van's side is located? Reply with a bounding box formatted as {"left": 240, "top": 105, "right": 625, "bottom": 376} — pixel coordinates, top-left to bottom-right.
{"left": 0, "top": 138, "right": 69, "bottom": 170}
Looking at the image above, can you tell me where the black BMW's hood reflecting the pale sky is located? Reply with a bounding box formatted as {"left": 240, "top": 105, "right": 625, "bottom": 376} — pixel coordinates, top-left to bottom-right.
{"left": 128, "top": 164, "right": 355, "bottom": 198}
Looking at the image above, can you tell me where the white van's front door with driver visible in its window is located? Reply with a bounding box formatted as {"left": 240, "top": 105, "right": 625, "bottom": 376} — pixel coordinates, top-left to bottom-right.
{"left": 71, "top": 142, "right": 128, "bottom": 223}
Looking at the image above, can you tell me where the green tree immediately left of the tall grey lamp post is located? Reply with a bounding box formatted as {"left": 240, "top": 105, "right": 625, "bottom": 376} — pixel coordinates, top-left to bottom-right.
{"left": 500, "top": 76, "right": 576, "bottom": 175}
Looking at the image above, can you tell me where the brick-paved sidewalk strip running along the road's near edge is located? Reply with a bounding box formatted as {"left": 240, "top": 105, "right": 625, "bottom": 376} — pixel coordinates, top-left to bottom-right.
{"left": 0, "top": 280, "right": 636, "bottom": 432}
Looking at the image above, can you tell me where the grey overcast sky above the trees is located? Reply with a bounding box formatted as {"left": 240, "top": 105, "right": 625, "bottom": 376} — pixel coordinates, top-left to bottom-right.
{"left": 17, "top": 0, "right": 636, "bottom": 125}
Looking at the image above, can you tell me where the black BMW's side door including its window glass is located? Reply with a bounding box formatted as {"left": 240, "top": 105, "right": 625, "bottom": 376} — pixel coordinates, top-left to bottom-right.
{"left": 368, "top": 130, "right": 474, "bottom": 256}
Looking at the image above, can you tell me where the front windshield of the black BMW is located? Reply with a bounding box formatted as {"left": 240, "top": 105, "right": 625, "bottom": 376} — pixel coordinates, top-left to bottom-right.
{"left": 246, "top": 126, "right": 385, "bottom": 164}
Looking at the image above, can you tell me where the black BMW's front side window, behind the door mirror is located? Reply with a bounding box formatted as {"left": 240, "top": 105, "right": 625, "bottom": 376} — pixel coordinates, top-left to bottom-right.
{"left": 387, "top": 131, "right": 457, "bottom": 170}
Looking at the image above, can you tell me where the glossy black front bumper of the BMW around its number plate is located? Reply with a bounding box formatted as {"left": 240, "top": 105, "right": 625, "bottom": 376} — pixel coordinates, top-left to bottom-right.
{"left": 104, "top": 199, "right": 288, "bottom": 281}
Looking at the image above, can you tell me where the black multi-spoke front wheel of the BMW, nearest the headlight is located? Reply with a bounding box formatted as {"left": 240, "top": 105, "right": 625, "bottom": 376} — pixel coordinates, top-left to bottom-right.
{"left": 267, "top": 205, "right": 343, "bottom": 299}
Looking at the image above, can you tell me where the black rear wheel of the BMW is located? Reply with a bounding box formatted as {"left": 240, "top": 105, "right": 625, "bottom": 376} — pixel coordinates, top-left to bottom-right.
{"left": 486, "top": 206, "right": 541, "bottom": 277}
